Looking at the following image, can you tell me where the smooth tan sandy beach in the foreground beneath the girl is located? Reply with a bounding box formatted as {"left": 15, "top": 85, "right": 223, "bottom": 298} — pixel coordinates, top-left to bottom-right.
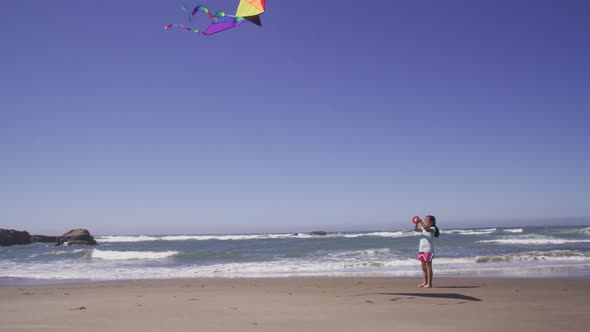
{"left": 0, "top": 277, "right": 590, "bottom": 332}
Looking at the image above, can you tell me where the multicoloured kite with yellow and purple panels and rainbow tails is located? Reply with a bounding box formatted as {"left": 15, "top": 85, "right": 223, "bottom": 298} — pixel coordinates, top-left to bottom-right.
{"left": 164, "top": 0, "right": 265, "bottom": 36}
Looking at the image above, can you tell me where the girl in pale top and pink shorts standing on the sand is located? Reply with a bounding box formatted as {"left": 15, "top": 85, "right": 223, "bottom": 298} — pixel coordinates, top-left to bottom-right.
{"left": 414, "top": 216, "right": 440, "bottom": 288}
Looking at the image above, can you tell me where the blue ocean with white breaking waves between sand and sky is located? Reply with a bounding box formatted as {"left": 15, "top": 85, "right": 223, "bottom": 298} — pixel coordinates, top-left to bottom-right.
{"left": 0, "top": 226, "right": 590, "bottom": 285}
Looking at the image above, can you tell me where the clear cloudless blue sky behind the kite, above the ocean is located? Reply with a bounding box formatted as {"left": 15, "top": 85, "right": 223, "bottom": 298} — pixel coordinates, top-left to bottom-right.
{"left": 0, "top": 0, "right": 590, "bottom": 234}
